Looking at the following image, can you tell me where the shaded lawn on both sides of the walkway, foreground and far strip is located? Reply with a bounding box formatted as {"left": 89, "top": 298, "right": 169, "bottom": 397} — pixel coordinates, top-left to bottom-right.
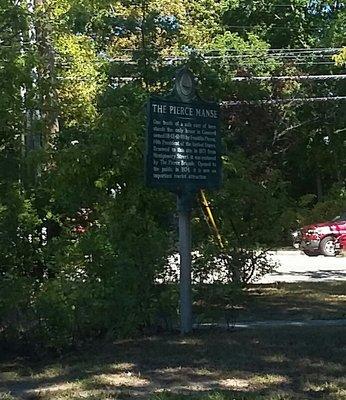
{"left": 0, "top": 284, "right": 346, "bottom": 400}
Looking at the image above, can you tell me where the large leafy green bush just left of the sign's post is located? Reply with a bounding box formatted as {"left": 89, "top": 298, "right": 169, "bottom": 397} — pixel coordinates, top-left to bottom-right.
{"left": 0, "top": 188, "right": 174, "bottom": 351}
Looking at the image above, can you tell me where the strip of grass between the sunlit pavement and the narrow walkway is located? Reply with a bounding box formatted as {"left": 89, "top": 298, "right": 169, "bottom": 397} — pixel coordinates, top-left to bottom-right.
{"left": 195, "top": 281, "right": 346, "bottom": 322}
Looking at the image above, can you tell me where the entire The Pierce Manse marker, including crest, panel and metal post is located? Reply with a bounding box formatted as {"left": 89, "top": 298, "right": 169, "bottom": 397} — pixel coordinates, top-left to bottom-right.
{"left": 146, "top": 68, "right": 221, "bottom": 334}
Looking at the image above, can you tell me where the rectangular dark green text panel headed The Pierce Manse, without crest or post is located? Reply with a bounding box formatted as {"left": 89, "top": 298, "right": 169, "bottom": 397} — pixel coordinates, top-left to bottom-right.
{"left": 146, "top": 98, "right": 221, "bottom": 191}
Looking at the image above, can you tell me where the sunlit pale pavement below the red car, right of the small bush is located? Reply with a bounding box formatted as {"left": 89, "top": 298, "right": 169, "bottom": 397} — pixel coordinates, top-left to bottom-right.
{"left": 258, "top": 250, "right": 346, "bottom": 283}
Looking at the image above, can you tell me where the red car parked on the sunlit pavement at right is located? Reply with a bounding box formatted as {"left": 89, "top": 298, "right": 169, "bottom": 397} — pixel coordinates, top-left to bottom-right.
{"left": 292, "top": 212, "right": 346, "bottom": 257}
